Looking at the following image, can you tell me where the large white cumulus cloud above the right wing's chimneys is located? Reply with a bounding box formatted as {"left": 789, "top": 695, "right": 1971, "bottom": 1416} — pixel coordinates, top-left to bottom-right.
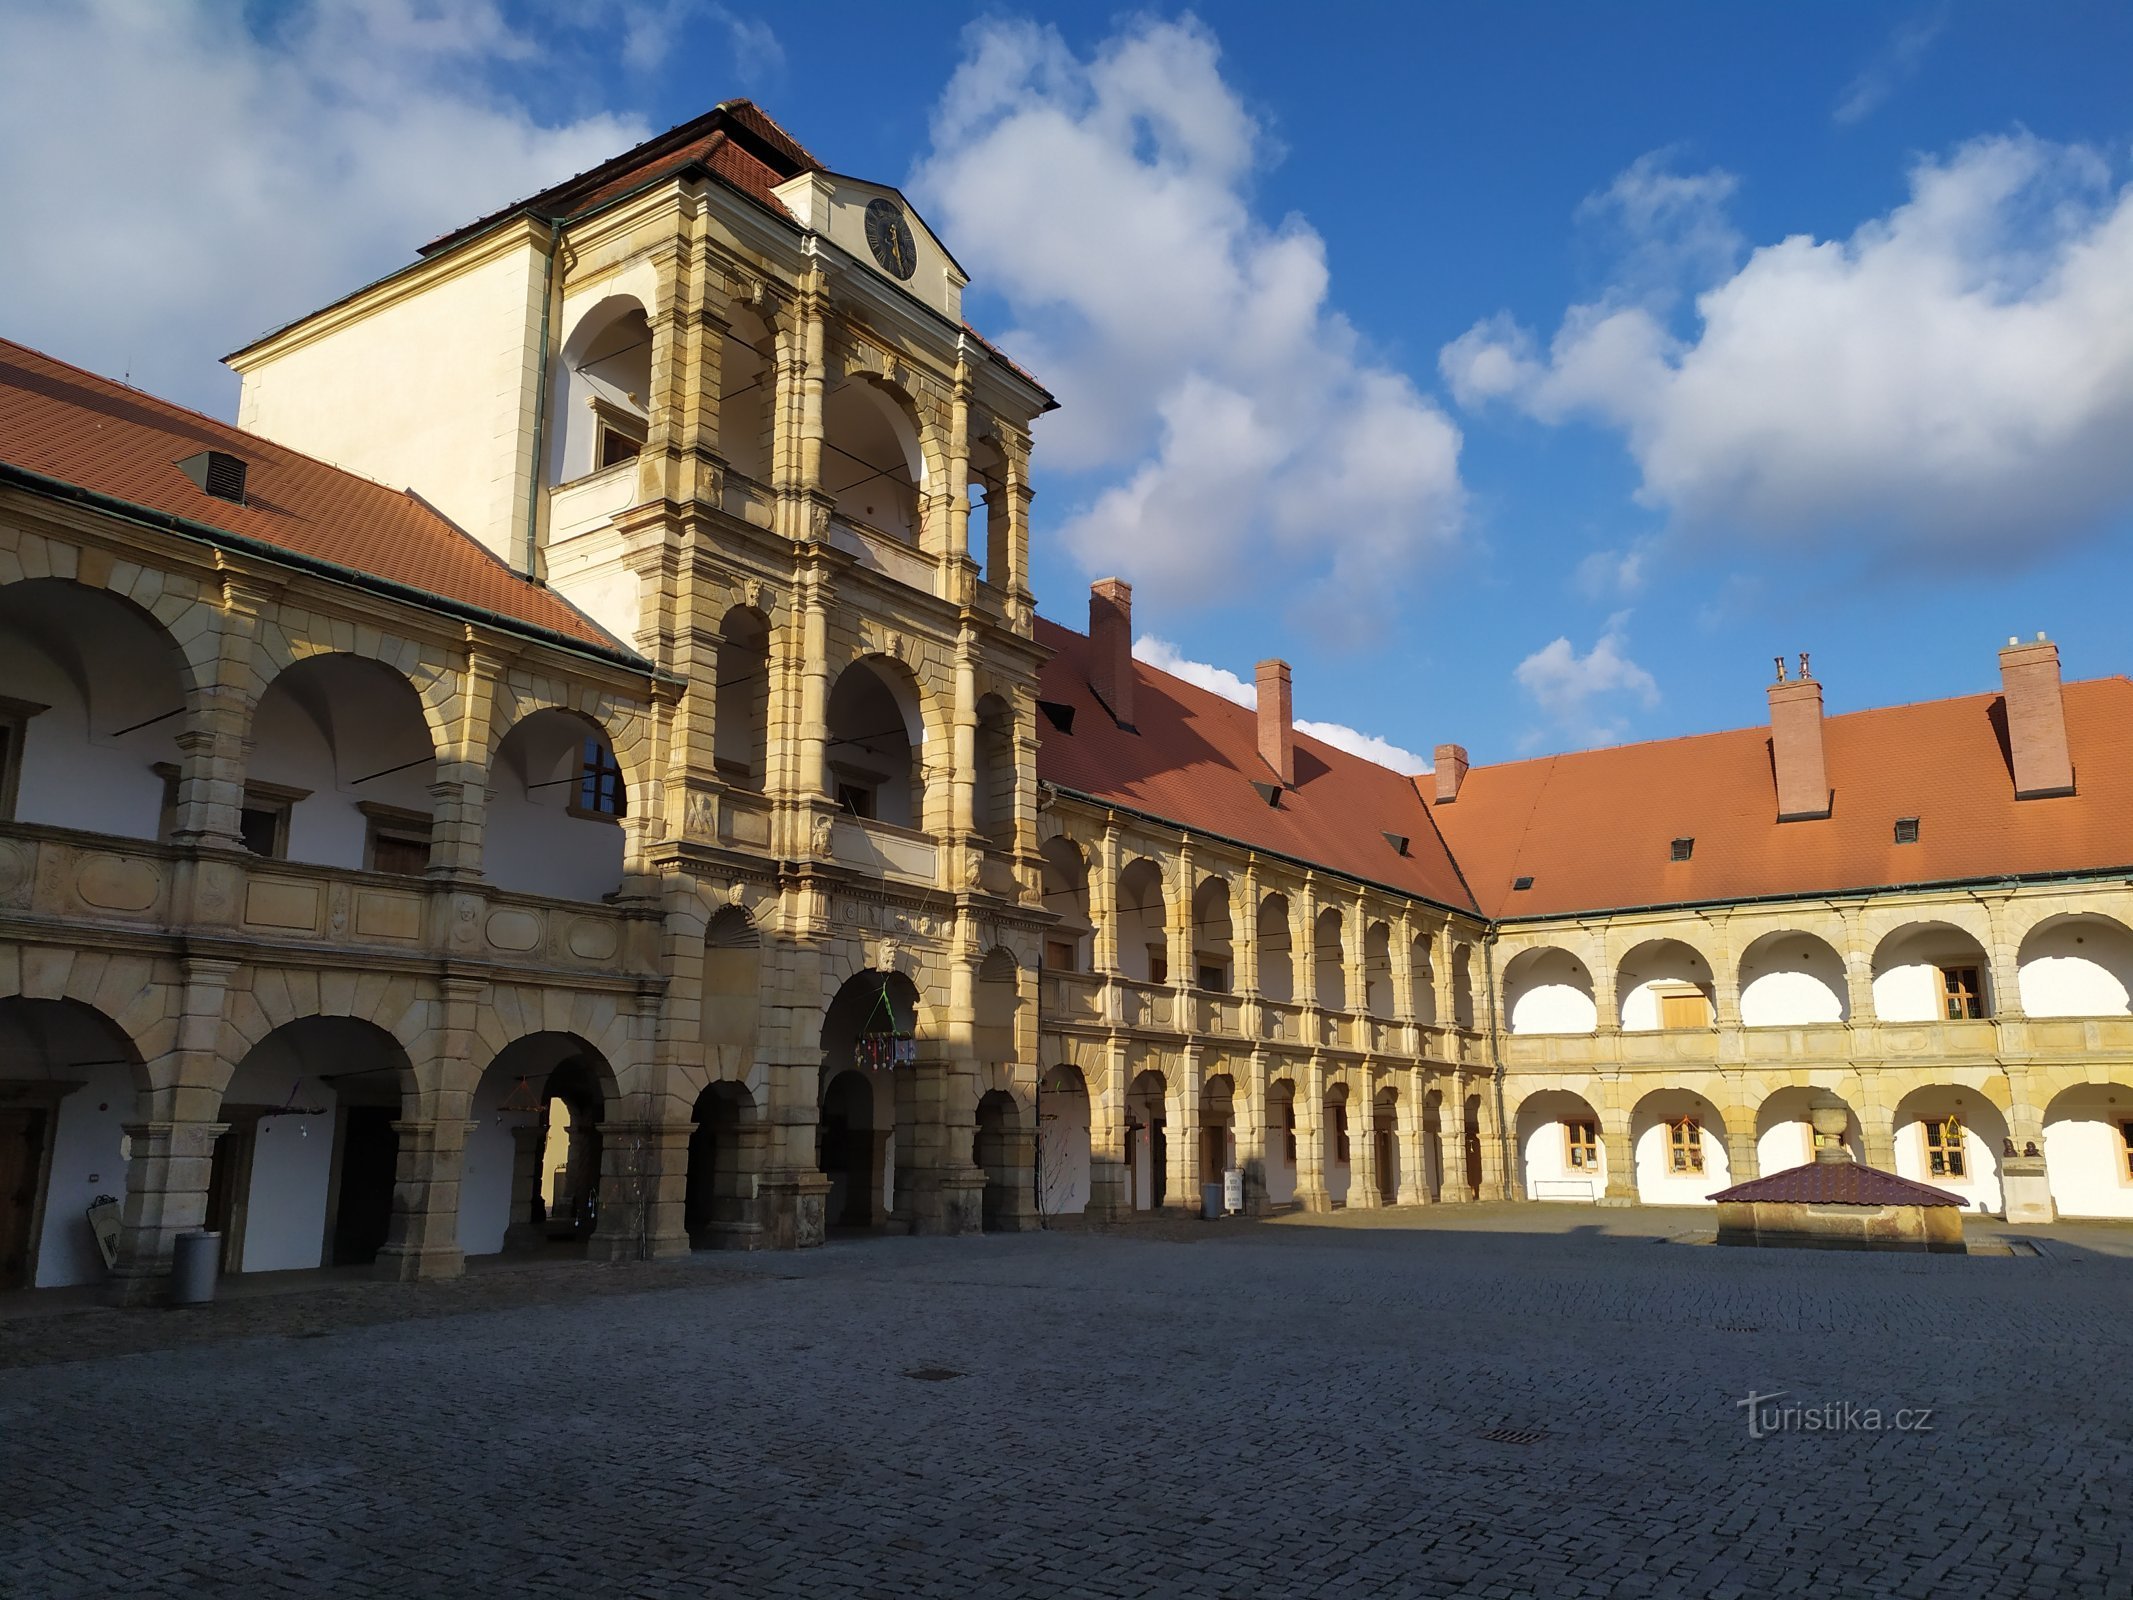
{"left": 1440, "top": 134, "right": 2133, "bottom": 561}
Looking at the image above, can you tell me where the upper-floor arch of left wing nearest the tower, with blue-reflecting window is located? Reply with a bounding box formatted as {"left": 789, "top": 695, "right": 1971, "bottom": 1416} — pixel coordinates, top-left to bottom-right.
{"left": 482, "top": 706, "right": 629, "bottom": 900}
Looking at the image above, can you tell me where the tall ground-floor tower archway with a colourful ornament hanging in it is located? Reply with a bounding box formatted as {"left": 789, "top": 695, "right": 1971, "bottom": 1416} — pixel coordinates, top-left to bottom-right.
{"left": 819, "top": 971, "right": 924, "bottom": 1227}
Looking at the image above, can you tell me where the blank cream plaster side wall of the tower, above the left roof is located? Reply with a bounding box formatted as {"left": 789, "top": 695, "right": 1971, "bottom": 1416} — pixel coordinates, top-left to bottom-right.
{"left": 237, "top": 241, "right": 544, "bottom": 559}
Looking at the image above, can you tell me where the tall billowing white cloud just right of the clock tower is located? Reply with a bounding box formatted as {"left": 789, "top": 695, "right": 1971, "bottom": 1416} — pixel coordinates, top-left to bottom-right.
{"left": 913, "top": 17, "right": 1463, "bottom": 634}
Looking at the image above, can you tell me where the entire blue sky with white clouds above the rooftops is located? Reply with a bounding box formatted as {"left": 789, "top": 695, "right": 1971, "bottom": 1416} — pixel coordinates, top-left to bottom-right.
{"left": 0, "top": 0, "right": 2133, "bottom": 759}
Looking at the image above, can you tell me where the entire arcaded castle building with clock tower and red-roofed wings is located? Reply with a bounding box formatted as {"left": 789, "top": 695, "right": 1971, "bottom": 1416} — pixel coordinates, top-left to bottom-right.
{"left": 0, "top": 102, "right": 2133, "bottom": 1297}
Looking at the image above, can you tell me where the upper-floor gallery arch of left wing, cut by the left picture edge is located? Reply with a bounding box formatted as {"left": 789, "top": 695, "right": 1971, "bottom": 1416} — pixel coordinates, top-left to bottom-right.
{"left": 0, "top": 578, "right": 188, "bottom": 838}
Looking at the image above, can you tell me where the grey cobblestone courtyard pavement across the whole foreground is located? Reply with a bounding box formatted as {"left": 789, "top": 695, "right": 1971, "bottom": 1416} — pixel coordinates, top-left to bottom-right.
{"left": 0, "top": 1207, "right": 2133, "bottom": 1600}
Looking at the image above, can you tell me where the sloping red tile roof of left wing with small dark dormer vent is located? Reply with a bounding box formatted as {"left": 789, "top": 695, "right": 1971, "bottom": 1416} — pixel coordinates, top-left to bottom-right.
{"left": 0, "top": 339, "right": 627, "bottom": 655}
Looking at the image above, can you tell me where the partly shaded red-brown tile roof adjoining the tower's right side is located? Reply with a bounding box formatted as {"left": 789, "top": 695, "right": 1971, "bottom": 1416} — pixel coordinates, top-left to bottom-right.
{"left": 1037, "top": 617, "right": 1474, "bottom": 911}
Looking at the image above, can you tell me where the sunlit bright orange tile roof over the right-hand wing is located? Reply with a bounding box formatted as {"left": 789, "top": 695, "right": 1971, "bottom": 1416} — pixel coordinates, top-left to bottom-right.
{"left": 1425, "top": 678, "right": 2133, "bottom": 917}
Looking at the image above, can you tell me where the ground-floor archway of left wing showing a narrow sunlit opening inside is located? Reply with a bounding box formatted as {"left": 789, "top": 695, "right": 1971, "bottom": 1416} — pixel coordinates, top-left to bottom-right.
{"left": 459, "top": 1033, "right": 614, "bottom": 1257}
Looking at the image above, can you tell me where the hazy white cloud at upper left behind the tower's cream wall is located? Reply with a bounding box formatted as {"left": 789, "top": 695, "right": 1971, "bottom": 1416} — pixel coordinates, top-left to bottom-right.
{"left": 0, "top": 0, "right": 665, "bottom": 412}
